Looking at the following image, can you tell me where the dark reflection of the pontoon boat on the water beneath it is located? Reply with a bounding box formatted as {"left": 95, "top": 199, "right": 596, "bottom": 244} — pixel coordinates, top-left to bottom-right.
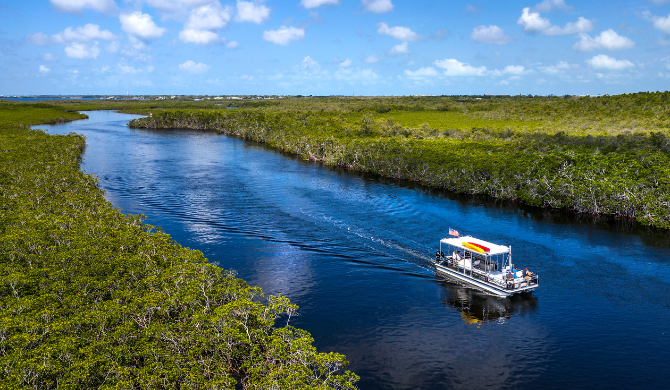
{"left": 436, "top": 276, "right": 538, "bottom": 325}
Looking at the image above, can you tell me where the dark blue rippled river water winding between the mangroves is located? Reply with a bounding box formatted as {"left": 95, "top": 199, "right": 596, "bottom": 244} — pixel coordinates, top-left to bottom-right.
{"left": 37, "top": 111, "right": 670, "bottom": 389}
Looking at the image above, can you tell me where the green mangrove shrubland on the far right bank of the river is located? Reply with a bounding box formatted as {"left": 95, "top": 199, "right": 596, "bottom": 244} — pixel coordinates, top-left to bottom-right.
{"left": 130, "top": 92, "right": 670, "bottom": 229}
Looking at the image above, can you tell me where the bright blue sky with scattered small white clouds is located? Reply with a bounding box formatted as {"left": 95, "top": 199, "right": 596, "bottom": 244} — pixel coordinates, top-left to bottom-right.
{"left": 0, "top": 0, "right": 670, "bottom": 95}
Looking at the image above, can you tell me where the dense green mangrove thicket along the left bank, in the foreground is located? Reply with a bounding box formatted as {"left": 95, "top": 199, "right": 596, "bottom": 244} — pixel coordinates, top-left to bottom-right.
{"left": 0, "top": 104, "right": 357, "bottom": 388}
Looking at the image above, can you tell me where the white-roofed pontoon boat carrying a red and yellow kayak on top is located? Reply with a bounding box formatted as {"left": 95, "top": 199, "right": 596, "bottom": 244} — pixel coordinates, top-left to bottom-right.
{"left": 435, "top": 236, "right": 539, "bottom": 296}
